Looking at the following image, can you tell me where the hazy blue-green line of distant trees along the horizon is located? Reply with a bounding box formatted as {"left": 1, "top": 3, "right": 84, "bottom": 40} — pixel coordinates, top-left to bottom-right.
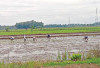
{"left": 0, "top": 20, "right": 100, "bottom": 31}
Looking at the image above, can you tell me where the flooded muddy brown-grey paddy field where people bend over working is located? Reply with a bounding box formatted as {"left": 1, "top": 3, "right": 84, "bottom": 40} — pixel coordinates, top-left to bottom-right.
{"left": 0, "top": 36, "right": 100, "bottom": 62}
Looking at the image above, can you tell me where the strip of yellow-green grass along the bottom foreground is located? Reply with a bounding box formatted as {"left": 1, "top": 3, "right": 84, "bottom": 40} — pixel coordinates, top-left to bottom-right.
{"left": 0, "top": 58, "right": 100, "bottom": 68}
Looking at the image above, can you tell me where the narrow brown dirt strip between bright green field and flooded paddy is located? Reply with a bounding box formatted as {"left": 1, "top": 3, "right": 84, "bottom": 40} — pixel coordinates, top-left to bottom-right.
{"left": 0, "top": 32, "right": 100, "bottom": 39}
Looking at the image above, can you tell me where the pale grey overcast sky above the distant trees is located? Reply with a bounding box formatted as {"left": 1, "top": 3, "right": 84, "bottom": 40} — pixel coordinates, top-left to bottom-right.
{"left": 0, "top": 0, "right": 100, "bottom": 25}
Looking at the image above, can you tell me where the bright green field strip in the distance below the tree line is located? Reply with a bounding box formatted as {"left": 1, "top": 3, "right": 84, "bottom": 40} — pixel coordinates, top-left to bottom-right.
{"left": 0, "top": 27, "right": 100, "bottom": 35}
